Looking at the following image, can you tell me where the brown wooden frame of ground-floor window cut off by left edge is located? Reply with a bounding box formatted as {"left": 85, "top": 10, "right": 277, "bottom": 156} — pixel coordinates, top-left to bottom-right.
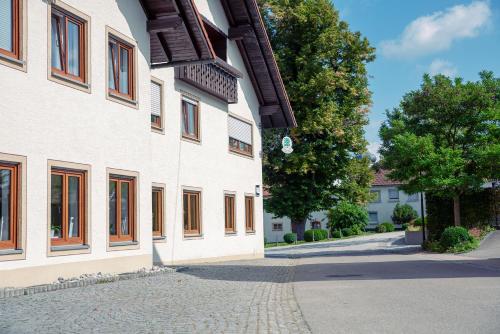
{"left": 0, "top": 162, "right": 20, "bottom": 250}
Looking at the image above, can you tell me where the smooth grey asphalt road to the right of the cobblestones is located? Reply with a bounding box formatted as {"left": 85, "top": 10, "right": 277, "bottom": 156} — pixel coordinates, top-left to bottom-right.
{"left": 267, "top": 232, "right": 500, "bottom": 334}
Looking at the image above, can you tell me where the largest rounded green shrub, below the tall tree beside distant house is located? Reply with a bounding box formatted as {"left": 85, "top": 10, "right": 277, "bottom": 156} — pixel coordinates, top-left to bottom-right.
{"left": 328, "top": 201, "right": 368, "bottom": 234}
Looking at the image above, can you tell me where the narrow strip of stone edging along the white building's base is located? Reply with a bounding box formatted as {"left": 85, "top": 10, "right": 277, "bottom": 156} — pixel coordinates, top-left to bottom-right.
{"left": 0, "top": 267, "right": 180, "bottom": 299}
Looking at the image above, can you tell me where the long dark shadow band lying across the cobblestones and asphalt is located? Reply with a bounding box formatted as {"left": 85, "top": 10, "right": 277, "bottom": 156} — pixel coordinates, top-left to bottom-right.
{"left": 183, "top": 258, "right": 500, "bottom": 283}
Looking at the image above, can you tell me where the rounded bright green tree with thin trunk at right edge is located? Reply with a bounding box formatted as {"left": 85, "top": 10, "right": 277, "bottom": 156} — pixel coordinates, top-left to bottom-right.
{"left": 380, "top": 72, "right": 500, "bottom": 226}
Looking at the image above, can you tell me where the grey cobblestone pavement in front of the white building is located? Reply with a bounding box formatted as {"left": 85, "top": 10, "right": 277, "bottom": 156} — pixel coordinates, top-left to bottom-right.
{"left": 0, "top": 259, "right": 309, "bottom": 334}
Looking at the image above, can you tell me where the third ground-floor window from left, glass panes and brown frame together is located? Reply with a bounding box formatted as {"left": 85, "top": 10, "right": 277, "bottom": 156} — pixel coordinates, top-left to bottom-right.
{"left": 109, "top": 175, "right": 135, "bottom": 242}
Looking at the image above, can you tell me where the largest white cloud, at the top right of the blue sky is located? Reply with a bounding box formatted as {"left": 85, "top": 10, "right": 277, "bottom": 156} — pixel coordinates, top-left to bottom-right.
{"left": 380, "top": 1, "right": 492, "bottom": 58}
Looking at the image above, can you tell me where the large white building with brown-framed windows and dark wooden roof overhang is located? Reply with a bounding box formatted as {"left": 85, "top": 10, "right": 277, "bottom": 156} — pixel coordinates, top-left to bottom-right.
{"left": 0, "top": 0, "right": 295, "bottom": 287}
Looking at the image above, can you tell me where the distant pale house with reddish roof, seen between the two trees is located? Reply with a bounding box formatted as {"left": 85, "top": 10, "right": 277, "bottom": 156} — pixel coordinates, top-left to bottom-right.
{"left": 368, "top": 169, "right": 422, "bottom": 228}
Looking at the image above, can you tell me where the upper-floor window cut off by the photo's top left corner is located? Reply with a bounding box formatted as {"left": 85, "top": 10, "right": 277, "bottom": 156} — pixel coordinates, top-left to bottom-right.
{"left": 0, "top": 0, "right": 21, "bottom": 59}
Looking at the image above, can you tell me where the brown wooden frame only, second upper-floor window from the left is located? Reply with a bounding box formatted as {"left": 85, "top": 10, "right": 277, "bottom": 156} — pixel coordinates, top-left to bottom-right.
{"left": 50, "top": 6, "right": 87, "bottom": 83}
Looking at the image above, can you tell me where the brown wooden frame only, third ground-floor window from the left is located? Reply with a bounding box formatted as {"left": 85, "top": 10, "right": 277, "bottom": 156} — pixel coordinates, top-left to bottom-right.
{"left": 108, "top": 174, "right": 136, "bottom": 243}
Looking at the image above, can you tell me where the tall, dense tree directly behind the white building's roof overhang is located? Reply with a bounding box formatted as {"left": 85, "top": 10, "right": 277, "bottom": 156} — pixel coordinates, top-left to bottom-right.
{"left": 260, "top": 0, "right": 375, "bottom": 239}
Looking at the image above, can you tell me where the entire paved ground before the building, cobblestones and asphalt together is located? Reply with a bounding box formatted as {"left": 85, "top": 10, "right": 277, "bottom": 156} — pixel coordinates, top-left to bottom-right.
{"left": 0, "top": 233, "right": 500, "bottom": 334}
